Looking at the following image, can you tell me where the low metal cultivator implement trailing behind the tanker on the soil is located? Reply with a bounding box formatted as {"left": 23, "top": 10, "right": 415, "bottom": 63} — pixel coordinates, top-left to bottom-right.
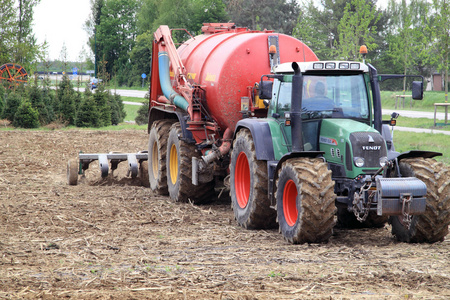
{"left": 67, "top": 151, "right": 148, "bottom": 185}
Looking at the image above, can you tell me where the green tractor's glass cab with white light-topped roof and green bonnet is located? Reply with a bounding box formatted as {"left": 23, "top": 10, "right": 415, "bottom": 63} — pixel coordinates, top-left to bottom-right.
{"left": 261, "top": 61, "right": 376, "bottom": 168}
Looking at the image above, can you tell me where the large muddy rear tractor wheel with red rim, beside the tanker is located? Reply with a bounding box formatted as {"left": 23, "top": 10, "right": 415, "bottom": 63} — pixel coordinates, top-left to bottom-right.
{"left": 230, "top": 129, "right": 276, "bottom": 229}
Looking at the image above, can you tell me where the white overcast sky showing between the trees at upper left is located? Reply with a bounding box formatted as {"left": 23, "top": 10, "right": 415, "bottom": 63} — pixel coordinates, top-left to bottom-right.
{"left": 34, "top": 0, "right": 388, "bottom": 61}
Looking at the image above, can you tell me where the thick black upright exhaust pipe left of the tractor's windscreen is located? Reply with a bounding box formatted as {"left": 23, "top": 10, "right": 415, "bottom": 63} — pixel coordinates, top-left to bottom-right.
{"left": 291, "top": 62, "right": 303, "bottom": 152}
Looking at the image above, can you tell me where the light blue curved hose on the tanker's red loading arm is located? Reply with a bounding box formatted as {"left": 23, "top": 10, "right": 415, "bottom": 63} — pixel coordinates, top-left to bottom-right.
{"left": 158, "top": 51, "right": 189, "bottom": 111}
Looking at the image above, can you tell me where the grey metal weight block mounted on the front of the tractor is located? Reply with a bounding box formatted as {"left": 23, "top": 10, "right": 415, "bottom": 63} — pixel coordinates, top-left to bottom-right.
{"left": 376, "top": 177, "right": 427, "bottom": 216}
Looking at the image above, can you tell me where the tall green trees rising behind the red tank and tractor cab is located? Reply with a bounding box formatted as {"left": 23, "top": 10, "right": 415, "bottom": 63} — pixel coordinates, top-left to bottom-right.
{"left": 86, "top": 0, "right": 450, "bottom": 98}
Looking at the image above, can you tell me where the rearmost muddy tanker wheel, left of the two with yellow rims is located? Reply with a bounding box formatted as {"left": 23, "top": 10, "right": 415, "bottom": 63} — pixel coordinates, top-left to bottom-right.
{"left": 147, "top": 120, "right": 173, "bottom": 195}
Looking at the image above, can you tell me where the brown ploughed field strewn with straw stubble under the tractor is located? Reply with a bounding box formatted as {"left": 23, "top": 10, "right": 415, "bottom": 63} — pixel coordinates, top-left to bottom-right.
{"left": 0, "top": 130, "right": 450, "bottom": 299}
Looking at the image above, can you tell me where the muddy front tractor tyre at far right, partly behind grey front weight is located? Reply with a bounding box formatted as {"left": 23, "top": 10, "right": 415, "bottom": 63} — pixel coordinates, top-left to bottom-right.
{"left": 389, "top": 158, "right": 450, "bottom": 243}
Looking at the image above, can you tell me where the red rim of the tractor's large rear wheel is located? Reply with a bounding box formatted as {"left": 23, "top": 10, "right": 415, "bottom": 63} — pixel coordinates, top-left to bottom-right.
{"left": 234, "top": 152, "right": 251, "bottom": 208}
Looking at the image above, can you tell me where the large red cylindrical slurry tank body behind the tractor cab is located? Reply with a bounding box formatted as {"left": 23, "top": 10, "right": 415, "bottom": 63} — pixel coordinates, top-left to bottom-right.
{"left": 177, "top": 24, "right": 318, "bottom": 132}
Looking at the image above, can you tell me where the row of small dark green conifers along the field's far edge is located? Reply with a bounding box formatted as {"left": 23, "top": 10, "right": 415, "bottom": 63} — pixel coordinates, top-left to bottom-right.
{"left": 0, "top": 76, "right": 126, "bottom": 128}
